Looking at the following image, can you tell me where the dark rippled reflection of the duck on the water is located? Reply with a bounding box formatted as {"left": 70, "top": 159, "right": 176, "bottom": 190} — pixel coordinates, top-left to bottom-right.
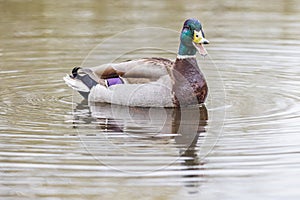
{"left": 74, "top": 102, "right": 208, "bottom": 191}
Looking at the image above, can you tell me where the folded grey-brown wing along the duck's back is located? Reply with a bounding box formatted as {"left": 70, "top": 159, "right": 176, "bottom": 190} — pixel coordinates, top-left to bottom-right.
{"left": 90, "top": 58, "right": 174, "bottom": 79}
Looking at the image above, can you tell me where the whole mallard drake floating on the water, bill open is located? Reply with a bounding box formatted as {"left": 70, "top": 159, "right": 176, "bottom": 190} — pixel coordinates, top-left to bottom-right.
{"left": 64, "top": 19, "right": 209, "bottom": 107}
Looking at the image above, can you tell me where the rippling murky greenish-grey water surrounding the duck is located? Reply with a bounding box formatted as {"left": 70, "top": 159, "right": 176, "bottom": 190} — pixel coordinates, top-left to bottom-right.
{"left": 0, "top": 0, "right": 300, "bottom": 200}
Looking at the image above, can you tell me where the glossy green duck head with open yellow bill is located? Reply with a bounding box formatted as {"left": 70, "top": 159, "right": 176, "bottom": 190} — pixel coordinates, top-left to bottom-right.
{"left": 178, "top": 19, "right": 209, "bottom": 56}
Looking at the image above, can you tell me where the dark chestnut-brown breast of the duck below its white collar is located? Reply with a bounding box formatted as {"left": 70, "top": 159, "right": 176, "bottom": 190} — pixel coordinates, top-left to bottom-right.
{"left": 171, "top": 58, "right": 208, "bottom": 106}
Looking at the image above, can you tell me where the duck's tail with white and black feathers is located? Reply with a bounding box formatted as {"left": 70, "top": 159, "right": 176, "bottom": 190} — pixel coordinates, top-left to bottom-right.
{"left": 63, "top": 67, "right": 98, "bottom": 99}
